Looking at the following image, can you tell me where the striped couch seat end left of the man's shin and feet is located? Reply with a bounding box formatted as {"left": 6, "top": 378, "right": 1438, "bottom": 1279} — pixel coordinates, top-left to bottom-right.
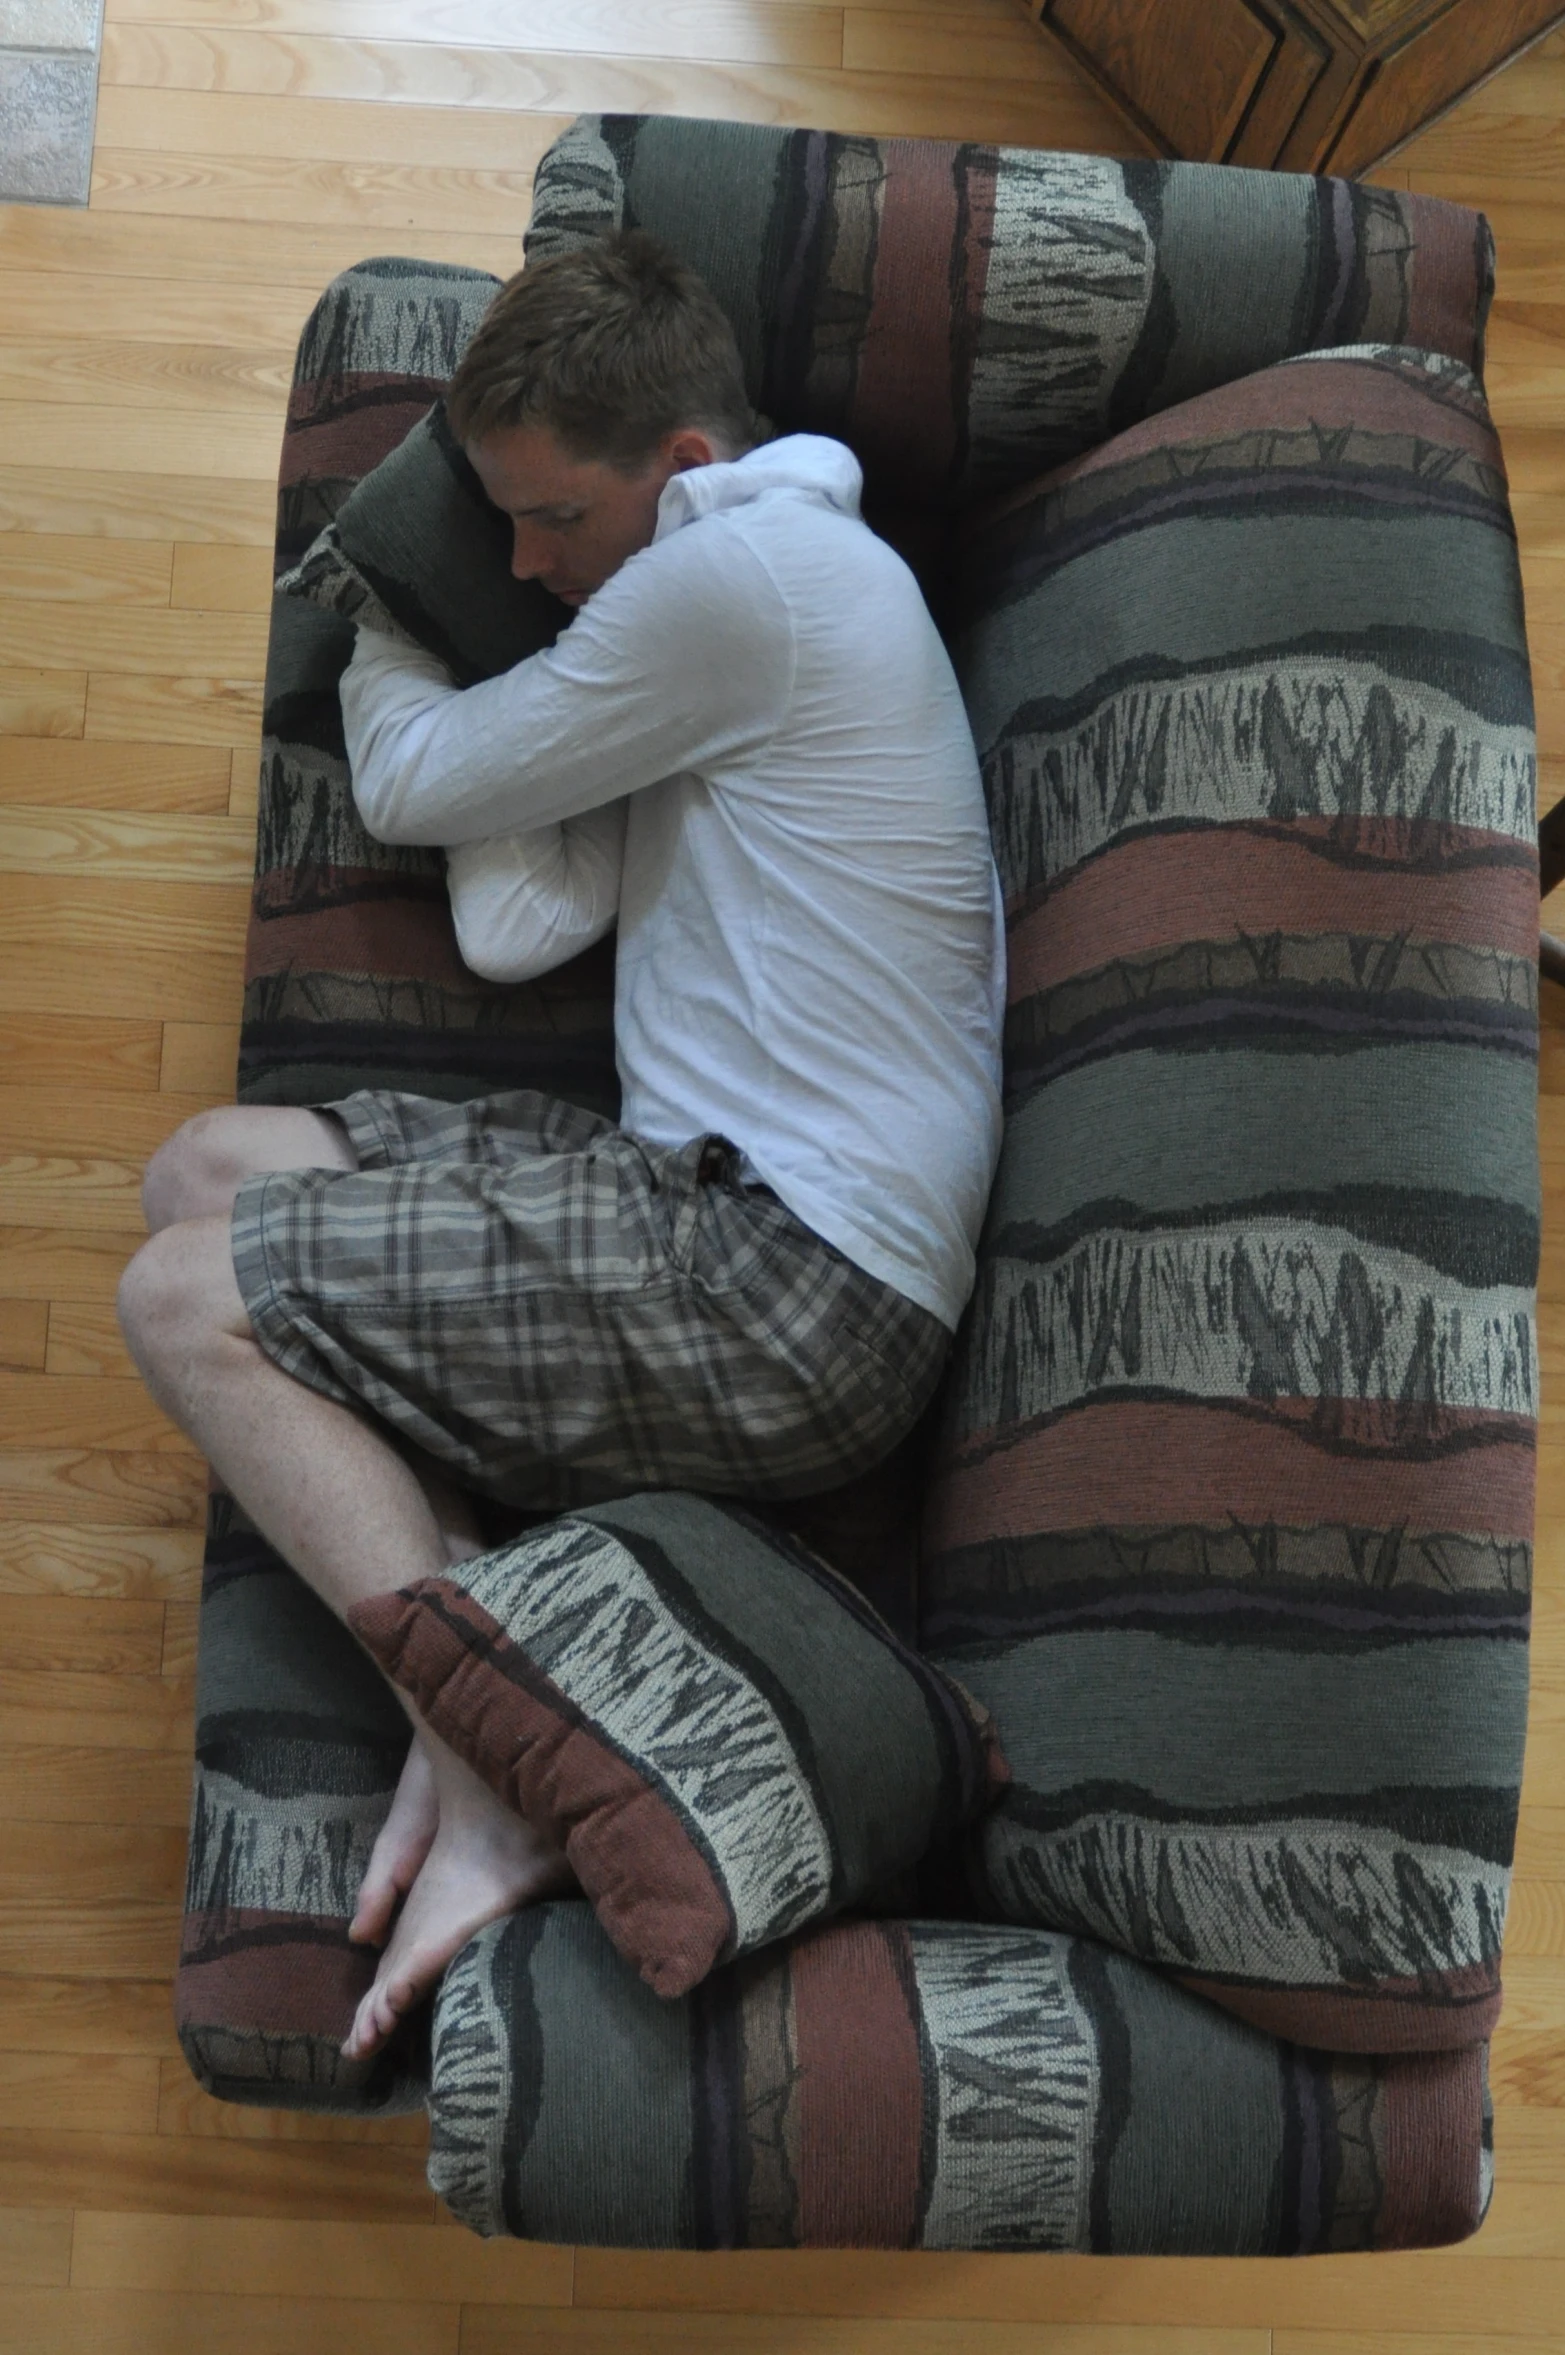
{"left": 174, "top": 1495, "right": 426, "bottom": 2110}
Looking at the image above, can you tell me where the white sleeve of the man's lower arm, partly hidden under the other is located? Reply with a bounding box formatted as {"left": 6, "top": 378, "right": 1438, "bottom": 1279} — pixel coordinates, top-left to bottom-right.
{"left": 447, "top": 801, "right": 626, "bottom": 982}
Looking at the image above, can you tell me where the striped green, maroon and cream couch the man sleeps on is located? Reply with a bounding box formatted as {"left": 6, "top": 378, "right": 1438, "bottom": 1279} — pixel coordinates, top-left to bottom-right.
{"left": 179, "top": 118, "right": 1537, "bottom": 2254}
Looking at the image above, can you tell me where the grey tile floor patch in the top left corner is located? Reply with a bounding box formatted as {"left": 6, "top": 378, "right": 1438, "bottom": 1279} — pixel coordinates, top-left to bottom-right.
{"left": 0, "top": 0, "right": 104, "bottom": 205}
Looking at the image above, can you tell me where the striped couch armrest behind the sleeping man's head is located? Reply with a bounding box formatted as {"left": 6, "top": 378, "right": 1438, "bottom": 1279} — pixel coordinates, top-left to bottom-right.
{"left": 527, "top": 115, "right": 1492, "bottom": 515}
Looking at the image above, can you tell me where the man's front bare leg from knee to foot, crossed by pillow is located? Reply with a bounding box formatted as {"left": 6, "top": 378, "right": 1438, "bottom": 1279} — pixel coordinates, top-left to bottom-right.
{"left": 120, "top": 1116, "right": 567, "bottom": 2058}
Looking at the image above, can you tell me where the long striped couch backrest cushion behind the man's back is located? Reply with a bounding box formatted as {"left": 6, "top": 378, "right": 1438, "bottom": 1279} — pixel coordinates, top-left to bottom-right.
{"left": 923, "top": 349, "right": 1539, "bottom": 2051}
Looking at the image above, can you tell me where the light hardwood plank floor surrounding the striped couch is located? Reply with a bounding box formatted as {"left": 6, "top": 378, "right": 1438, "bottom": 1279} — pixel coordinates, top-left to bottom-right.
{"left": 0, "top": 0, "right": 1565, "bottom": 2355}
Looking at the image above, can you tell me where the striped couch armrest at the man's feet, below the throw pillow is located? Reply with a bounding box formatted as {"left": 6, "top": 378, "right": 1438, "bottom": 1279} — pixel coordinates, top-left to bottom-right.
{"left": 431, "top": 1905, "right": 1492, "bottom": 2241}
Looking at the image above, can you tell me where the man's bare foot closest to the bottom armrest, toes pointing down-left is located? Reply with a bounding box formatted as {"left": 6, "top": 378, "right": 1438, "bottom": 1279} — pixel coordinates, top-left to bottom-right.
{"left": 341, "top": 1747, "right": 572, "bottom": 2061}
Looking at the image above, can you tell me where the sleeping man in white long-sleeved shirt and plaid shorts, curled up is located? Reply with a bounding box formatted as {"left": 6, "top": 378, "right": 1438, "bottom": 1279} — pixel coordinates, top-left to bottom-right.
{"left": 120, "top": 236, "right": 1003, "bottom": 2056}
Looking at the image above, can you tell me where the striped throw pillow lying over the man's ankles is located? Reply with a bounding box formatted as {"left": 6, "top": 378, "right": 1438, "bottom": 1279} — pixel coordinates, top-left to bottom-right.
{"left": 351, "top": 1493, "right": 1005, "bottom": 1997}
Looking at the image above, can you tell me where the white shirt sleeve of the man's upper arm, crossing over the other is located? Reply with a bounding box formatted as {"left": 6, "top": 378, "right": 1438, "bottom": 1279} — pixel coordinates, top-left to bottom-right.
{"left": 341, "top": 516, "right": 793, "bottom": 848}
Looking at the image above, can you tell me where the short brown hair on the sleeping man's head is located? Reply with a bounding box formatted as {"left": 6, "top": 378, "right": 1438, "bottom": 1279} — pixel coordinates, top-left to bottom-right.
{"left": 445, "top": 228, "right": 760, "bottom": 473}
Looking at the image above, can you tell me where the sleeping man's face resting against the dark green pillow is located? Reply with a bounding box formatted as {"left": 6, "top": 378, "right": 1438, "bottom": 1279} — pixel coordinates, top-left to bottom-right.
{"left": 468, "top": 426, "right": 718, "bottom": 605}
